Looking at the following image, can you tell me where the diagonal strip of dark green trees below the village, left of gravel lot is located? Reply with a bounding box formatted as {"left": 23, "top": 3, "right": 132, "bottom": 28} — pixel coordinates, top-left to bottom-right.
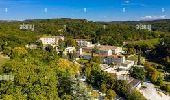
{"left": 84, "top": 59, "right": 145, "bottom": 100}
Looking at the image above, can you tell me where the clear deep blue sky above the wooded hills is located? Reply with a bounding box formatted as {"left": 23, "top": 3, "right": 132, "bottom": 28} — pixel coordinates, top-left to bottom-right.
{"left": 0, "top": 0, "right": 170, "bottom": 21}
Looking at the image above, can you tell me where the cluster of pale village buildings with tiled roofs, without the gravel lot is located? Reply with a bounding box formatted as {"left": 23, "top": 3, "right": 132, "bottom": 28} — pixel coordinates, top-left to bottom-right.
{"left": 26, "top": 36, "right": 144, "bottom": 89}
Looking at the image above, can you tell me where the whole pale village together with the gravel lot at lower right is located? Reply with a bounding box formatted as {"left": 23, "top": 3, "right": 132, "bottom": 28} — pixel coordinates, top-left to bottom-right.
{"left": 22, "top": 36, "right": 169, "bottom": 100}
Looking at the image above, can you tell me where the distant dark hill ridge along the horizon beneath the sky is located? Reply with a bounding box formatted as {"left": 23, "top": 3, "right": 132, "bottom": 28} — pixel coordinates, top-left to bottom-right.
{"left": 0, "top": 18, "right": 170, "bottom": 32}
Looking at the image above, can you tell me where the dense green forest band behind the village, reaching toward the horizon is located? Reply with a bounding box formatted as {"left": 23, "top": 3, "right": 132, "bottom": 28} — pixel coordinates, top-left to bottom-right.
{"left": 0, "top": 19, "right": 168, "bottom": 46}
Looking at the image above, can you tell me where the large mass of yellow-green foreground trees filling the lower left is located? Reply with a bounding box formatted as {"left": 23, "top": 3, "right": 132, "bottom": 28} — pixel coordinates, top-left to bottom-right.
{"left": 0, "top": 47, "right": 91, "bottom": 100}
